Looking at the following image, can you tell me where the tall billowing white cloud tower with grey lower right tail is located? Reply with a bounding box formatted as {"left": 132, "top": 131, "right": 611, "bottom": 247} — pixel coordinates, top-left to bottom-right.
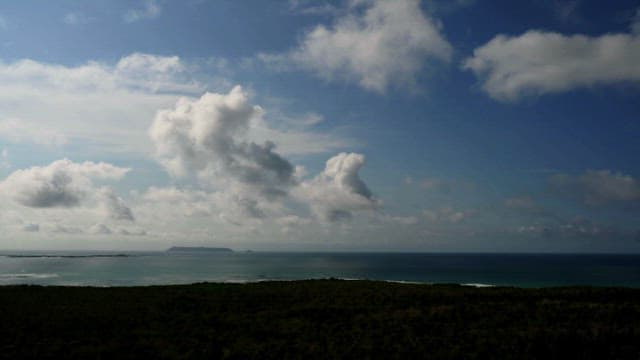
{"left": 149, "top": 86, "right": 295, "bottom": 197}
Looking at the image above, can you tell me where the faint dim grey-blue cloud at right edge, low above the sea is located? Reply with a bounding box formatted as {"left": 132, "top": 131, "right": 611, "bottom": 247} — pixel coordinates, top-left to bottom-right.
{"left": 549, "top": 170, "right": 640, "bottom": 206}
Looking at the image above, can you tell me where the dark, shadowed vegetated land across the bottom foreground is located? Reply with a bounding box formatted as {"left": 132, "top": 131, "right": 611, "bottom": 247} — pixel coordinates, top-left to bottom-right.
{"left": 0, "top": 280, "right": 640, "bottom": 359}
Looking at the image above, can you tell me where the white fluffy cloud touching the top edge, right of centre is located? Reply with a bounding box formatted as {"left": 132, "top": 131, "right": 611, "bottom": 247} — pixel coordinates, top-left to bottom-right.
{"left": 272, "top": 0, "right": 452, "bottom": 93}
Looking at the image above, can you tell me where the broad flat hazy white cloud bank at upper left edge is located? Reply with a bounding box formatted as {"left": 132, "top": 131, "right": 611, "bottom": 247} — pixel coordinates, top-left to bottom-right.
{"left": 0, "top": 53, "right": 204, "bottom": 154}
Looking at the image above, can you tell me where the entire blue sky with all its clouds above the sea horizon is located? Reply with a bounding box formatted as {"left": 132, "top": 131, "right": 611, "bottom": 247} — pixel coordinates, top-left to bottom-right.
{"left": 0, "top": 0, "right": 640, "bottom": 253}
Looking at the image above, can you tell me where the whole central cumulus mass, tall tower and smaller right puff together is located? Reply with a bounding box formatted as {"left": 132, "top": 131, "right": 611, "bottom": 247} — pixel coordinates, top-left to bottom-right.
{"left": 147, "top": 86, "right": 379, "bottom": 228}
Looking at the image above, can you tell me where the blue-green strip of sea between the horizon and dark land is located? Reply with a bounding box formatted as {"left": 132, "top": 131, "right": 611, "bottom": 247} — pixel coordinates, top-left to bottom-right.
{"left": 0, "top": 251, "right": 640, "bottom": 288}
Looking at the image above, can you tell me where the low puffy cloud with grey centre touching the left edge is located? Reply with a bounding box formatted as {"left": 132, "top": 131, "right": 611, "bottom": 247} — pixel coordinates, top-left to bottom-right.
{"left": 0, "top": 159, "right": 142, "bottom": 239}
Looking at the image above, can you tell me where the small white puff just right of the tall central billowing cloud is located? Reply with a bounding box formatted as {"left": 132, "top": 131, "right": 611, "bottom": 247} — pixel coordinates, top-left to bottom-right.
{"left": 296, "top": 153, "right": 381, "bottom": 222}
